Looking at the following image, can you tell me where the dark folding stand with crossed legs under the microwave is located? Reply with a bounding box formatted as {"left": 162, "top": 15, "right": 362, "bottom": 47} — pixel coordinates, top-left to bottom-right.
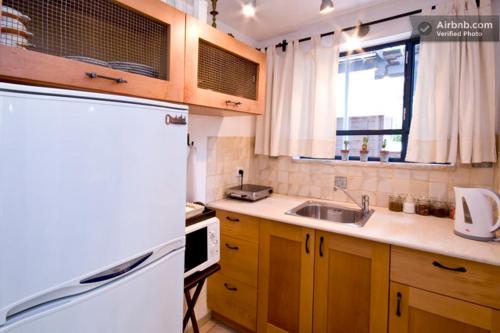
{"left": 183, "top": 264, "right": 220, "bottom": 333}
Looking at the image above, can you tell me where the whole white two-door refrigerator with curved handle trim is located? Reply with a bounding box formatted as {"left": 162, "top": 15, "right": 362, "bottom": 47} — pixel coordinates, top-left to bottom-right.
{"left": 0, "top": 83, "right": 187, "bottom": 333}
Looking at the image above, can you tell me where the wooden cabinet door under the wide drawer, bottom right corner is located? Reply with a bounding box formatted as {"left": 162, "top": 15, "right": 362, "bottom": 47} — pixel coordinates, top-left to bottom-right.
{"left": 389, "top": 282, "right": 500, "bottom": 333}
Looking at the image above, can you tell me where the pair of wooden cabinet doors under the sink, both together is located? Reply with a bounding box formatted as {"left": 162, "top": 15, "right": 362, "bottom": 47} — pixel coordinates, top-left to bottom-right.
{"left": 257, "top": 222, "right": 390, "bottom": 333}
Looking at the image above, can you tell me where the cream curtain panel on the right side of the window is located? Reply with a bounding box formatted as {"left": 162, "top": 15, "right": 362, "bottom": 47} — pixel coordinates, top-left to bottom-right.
{"left": 406, "top": 0, "right": 496, "bottom": 163}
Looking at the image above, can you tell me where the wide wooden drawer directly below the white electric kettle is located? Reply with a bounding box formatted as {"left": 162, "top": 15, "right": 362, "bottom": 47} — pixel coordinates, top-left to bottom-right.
{"left": 391, "top": 247, "right": 500, "bottom": 309}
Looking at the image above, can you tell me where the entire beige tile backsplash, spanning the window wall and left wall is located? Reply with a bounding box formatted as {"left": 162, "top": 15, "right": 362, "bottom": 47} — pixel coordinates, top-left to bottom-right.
{"left": 206, "top": 137, "right": 496, "bottom": 207}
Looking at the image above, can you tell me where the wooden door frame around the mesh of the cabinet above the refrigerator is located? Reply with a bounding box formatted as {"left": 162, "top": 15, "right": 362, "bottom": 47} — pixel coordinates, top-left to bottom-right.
{"left": 0, "top": 0, "right": 186, "bottom": 102}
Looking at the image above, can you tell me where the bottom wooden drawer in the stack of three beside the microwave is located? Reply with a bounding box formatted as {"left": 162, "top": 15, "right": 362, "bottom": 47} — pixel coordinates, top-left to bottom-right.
{"left": 208, "top": 272, "right": 257, "bottom": 331}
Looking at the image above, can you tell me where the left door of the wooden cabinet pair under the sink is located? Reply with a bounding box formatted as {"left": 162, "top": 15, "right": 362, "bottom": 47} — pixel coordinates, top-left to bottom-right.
{"left": 257, "top": 221, "right": 314, "bottom": 333}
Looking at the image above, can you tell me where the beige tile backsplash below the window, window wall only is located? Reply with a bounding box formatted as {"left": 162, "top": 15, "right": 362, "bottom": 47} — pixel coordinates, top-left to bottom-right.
{"left": 253, "top": 156, "right": 495, "bottom": 207}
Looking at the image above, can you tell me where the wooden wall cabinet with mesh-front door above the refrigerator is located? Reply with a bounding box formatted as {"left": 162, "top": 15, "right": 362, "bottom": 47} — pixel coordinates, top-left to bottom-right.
{"left": 0, "top": 0, "right": 185, "bottom": 102}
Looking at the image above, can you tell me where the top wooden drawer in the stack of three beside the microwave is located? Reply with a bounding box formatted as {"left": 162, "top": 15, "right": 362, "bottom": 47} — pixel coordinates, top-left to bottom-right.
{"left": 217, "top": 210, "right": 259, "bottom": 242}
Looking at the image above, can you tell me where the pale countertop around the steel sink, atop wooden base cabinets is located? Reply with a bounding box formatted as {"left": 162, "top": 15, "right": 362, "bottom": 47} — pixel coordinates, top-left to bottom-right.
{"left": 208, "top": 194, "right": 500, "bottom": 266}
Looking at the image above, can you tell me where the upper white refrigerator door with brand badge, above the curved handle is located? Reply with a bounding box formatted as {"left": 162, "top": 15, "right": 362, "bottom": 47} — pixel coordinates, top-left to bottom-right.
{"left": 0, "top": 83, "right": 187, "bottom": 324}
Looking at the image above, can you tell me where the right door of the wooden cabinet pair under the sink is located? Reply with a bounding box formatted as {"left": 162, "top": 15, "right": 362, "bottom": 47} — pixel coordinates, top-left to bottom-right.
{"left": 313, "top": 231, "right": 390, "bottom": 333}
